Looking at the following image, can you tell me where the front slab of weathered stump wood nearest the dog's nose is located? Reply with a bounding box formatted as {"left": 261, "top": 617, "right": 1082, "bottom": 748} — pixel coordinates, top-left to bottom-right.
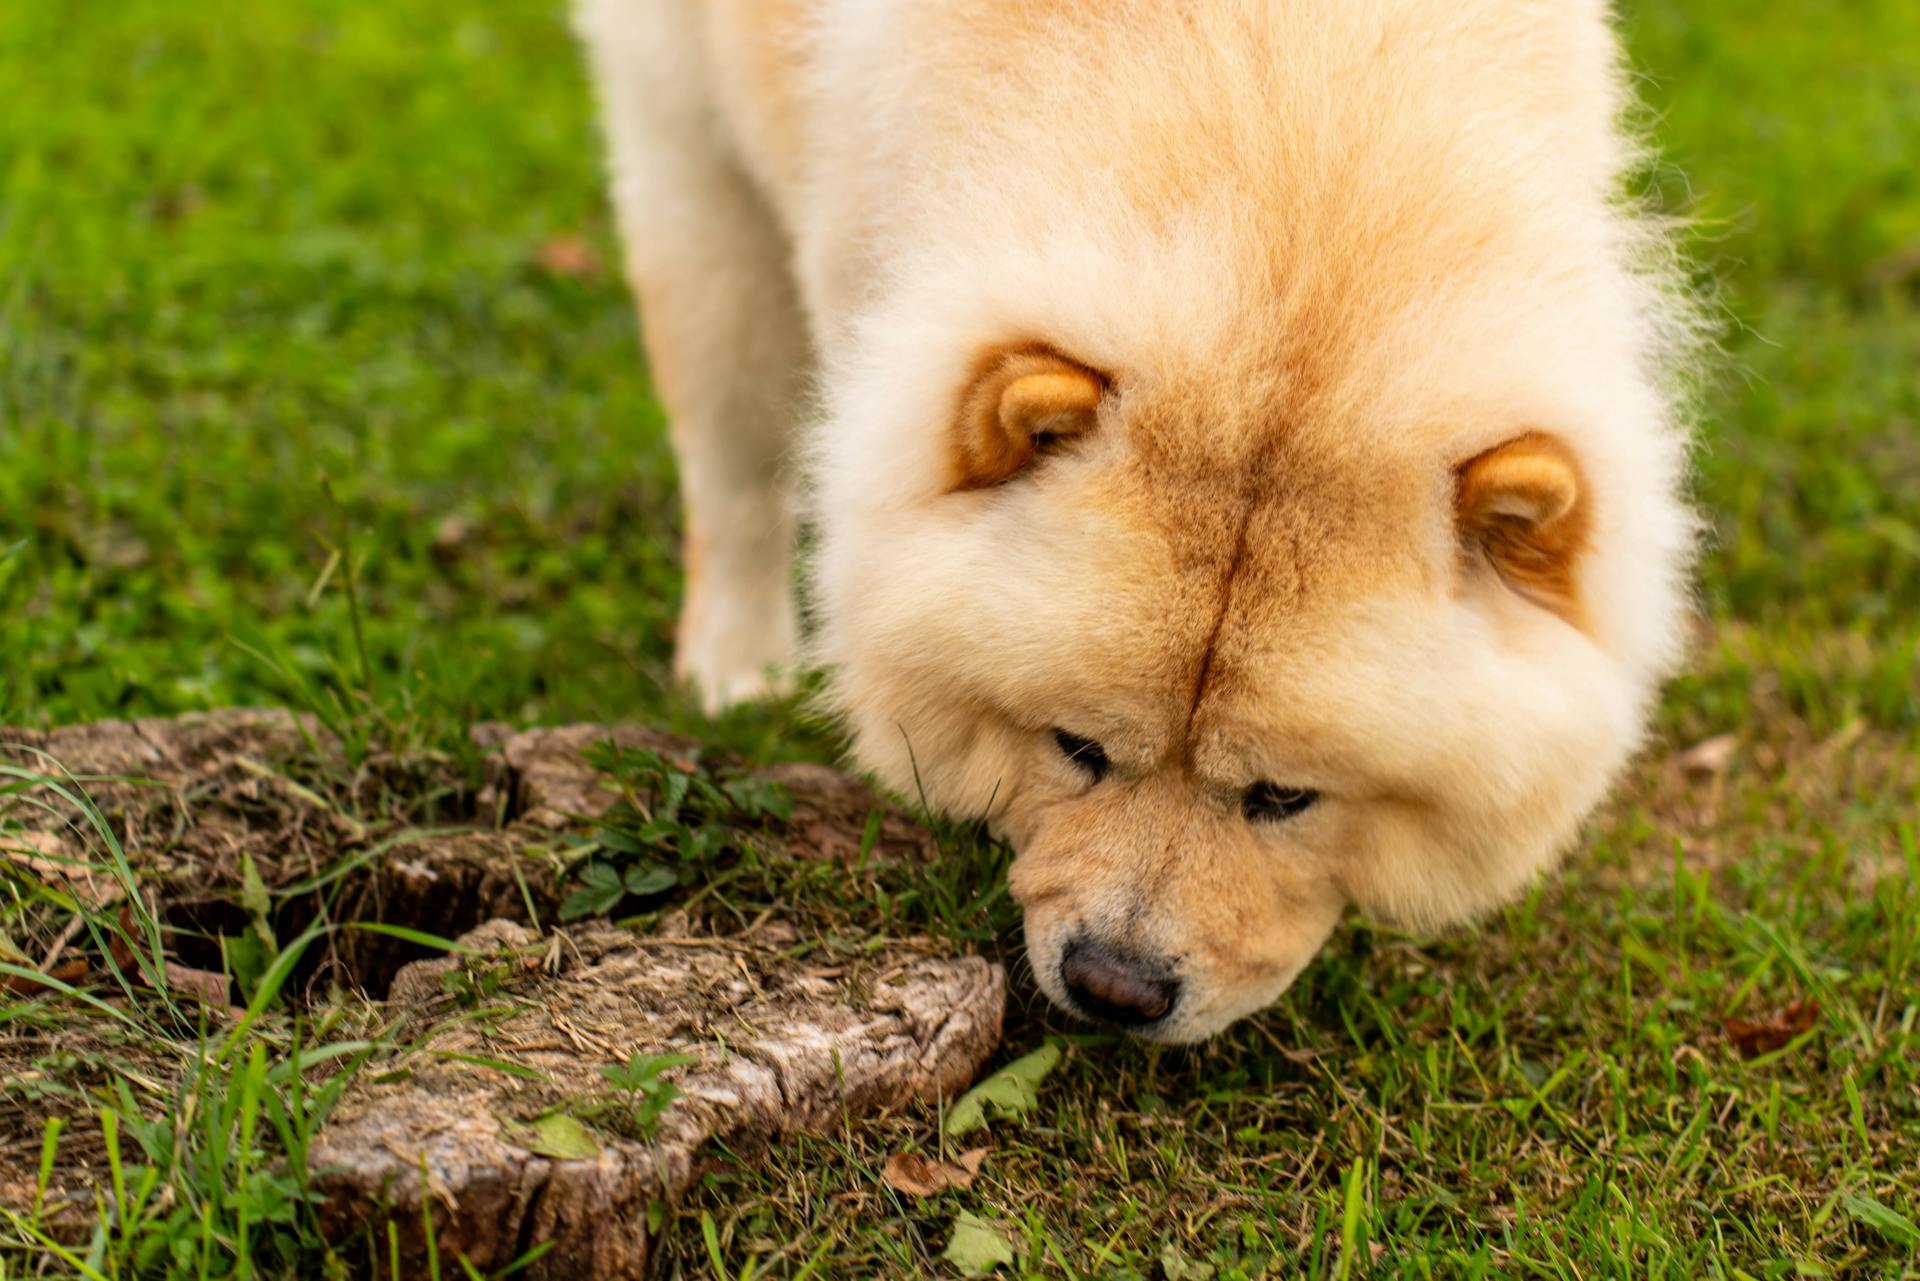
{"left": 313, "top": 922, "right": 1006, "bottom": 1279}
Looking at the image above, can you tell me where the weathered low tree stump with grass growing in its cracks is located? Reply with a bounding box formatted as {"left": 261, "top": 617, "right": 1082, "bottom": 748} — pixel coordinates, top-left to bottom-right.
{"left": 0, "top": 711, "right": 1006, "bottom": 1279}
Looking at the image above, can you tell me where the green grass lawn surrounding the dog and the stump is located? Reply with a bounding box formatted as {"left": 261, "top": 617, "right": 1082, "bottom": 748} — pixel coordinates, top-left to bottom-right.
{"left": 0, "top": 0, "right": 1920, "bottom": 1277}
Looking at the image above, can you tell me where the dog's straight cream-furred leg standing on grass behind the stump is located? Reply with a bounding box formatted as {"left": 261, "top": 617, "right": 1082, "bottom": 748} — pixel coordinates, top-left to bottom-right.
{"left": 593, "top": 17, "right": 808, "bottom": 711}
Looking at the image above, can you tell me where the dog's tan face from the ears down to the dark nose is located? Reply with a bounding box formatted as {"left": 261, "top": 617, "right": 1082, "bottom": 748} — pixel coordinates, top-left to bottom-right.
{"left": 824, "top": 330, "right": 1684, "bottom": 1041}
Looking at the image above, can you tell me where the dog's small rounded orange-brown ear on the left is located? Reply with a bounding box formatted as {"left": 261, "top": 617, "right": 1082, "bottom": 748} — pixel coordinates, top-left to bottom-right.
{"left": 952, "top": 348, "right": 1106, "bottom": 490}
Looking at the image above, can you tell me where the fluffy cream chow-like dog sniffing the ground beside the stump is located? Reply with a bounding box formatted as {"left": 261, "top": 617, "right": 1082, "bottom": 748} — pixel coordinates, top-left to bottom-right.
{"left": 580, "top": 0, "right": 1693, "bottom": 1041}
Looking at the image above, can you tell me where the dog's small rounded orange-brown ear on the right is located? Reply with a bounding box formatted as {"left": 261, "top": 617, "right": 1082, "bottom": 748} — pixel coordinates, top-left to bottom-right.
{"left": 1453, "top": 432, "right": 1594, "bottom": 626}
